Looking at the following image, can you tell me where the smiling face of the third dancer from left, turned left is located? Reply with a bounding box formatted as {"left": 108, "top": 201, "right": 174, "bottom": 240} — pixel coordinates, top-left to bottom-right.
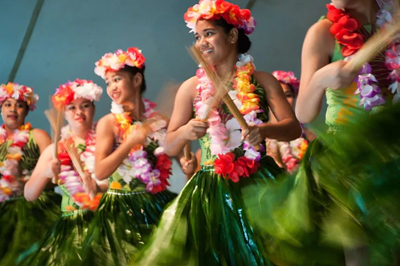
{"left": 105, "top": 71, "right": 142, "bottom": 104}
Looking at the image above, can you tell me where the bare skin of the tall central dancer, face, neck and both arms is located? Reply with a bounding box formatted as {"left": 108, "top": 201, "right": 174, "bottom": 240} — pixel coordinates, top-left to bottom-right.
{"left": 165, "top": 20, "right": 301, "bottom": 156}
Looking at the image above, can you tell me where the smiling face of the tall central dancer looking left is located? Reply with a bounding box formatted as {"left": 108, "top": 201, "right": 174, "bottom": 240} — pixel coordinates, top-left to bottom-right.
{"left": 195, "top": 20, "right": 237, "bottom": 66}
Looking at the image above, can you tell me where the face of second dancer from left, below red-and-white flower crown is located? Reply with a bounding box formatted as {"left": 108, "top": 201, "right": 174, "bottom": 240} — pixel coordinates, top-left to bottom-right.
{"left": 65, "top": 98, "right": 95, "bottom": 129}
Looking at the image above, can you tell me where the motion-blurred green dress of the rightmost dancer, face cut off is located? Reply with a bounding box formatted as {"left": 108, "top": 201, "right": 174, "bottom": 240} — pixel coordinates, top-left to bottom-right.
{"left": 245, "top": 18, "right": 400, "bottom": 265}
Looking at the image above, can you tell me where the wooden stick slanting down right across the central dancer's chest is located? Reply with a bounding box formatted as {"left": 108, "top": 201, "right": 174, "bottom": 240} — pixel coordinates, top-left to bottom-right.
{"left": 190, "top": 46, "right": 260, "bottom": 150}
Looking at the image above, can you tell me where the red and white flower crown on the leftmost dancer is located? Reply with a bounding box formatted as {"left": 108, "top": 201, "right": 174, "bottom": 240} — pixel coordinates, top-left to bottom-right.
{"left": 0, "top": 82, "right": 39, "bottom": 111}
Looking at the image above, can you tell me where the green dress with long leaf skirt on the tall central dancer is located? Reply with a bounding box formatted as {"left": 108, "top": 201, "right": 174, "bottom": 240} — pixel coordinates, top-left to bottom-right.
{"left": 132, "top": 78, "right": 282, "bottom": 266}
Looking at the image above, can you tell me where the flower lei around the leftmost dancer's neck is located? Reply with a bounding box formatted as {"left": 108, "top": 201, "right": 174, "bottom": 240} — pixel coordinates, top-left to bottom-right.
{"left": 0, "top": 122, "right": 32, "bottom": 202}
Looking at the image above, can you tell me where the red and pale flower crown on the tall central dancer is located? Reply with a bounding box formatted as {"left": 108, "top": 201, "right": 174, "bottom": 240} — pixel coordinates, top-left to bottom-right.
{"left": 184, "top": 0, "right": 256, "bottom": 34}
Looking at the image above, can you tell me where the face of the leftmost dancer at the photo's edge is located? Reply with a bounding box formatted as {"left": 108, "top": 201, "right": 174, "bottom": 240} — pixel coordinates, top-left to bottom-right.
{"left": 1, "top": 98, "right": 29, "bottom": 130}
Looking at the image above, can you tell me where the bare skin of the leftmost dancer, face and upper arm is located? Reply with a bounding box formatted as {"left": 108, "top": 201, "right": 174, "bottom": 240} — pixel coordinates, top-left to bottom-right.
{"left": 1, "top": 98, "right": 51, "bottom": 191}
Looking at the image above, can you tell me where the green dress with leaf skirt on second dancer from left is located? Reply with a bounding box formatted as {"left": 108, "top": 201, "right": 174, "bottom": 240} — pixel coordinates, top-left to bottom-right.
{"left": 18, "top": 144, "right": 94, "bottom": 266}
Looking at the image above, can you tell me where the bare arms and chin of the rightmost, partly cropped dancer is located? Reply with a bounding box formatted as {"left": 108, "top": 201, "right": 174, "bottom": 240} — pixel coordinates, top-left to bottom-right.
{"left": 296, "top": 0, "right": 379, "bottom": 123}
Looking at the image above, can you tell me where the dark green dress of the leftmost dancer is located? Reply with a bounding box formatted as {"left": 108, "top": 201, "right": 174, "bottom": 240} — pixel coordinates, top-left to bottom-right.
{"left": 0, "top": 130, "right": 61, "bottom": 266}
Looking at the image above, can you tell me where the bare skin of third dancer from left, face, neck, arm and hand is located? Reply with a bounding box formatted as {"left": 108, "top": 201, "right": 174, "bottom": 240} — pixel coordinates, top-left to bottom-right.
{"left": 95, "top": 71, "right": 196, "bottom": 180}
